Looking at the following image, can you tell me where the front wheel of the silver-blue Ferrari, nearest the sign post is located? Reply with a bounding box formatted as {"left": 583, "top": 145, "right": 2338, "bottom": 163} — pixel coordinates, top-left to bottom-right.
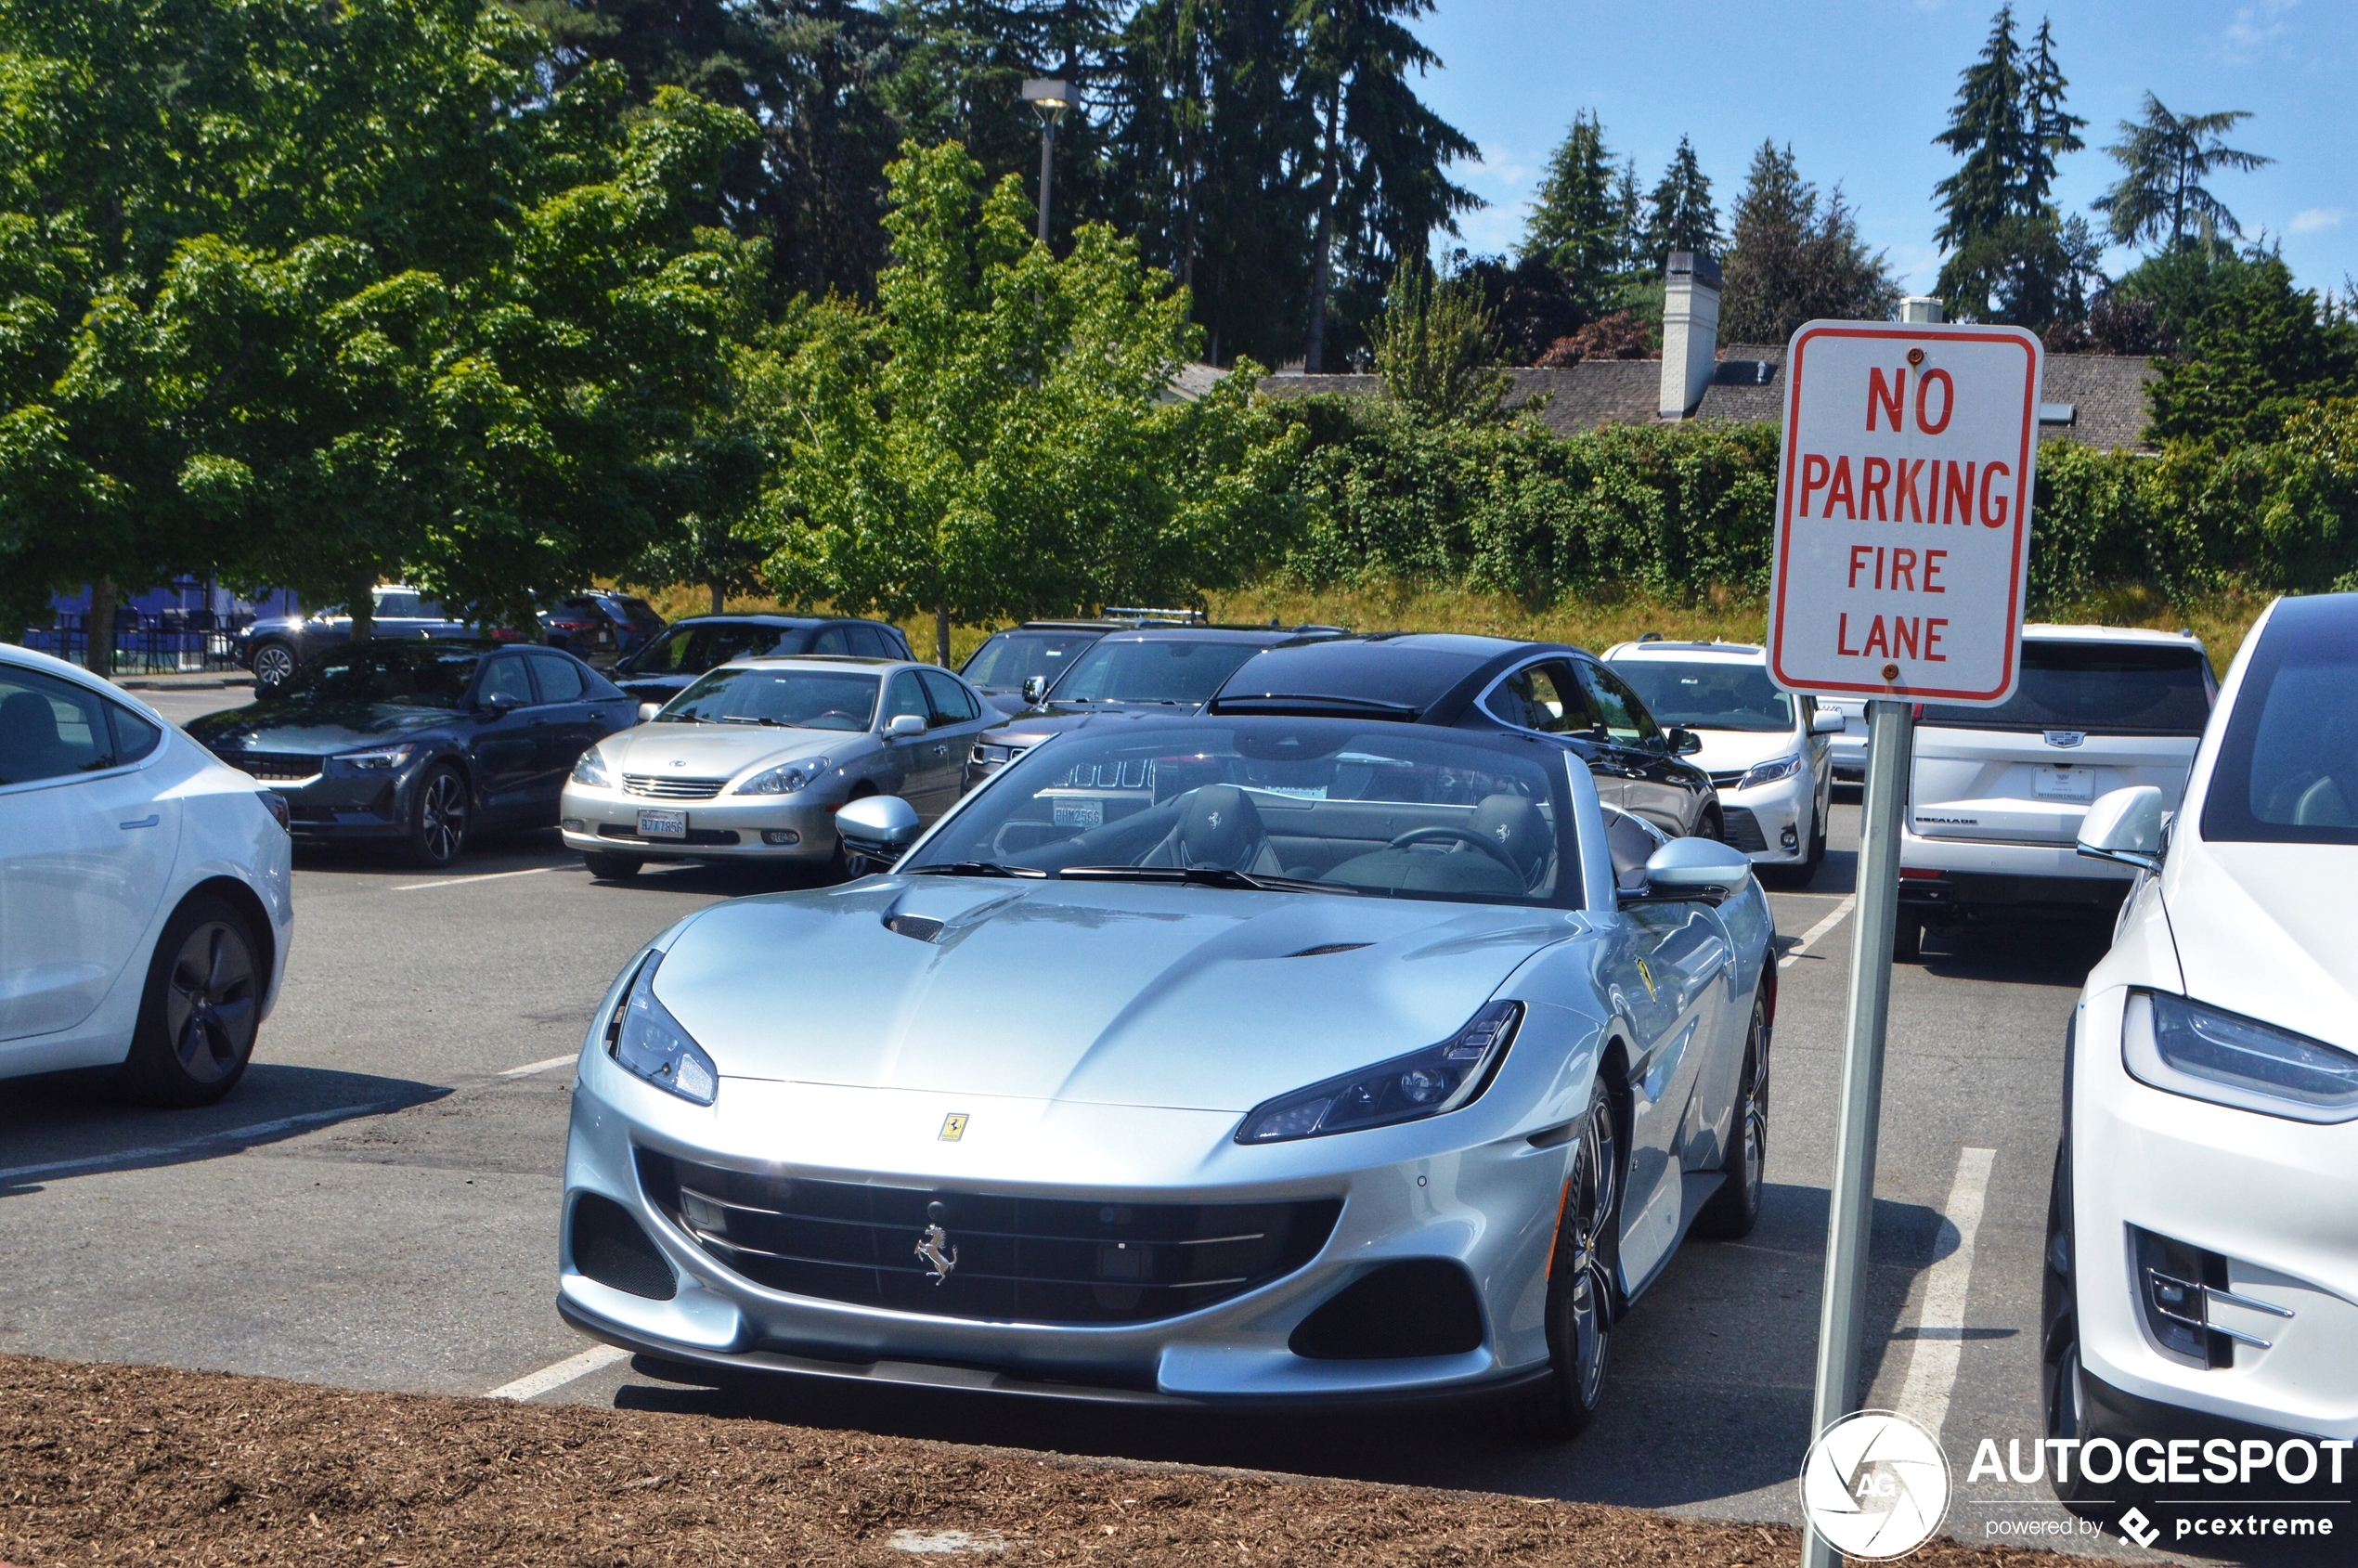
{"left": 1502, "top": 1082, "right": 1623, "bottom": 1443}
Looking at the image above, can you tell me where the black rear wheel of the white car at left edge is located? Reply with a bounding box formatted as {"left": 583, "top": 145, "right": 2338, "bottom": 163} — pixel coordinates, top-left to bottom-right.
{"left": 115, "top": 894, "right": 269, "bottom": 1106}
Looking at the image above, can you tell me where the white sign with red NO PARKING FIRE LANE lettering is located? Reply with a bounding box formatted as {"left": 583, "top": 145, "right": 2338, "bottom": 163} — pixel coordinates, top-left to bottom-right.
{"left": 1768, "top": 320, "right": 2042, "bottom": 705}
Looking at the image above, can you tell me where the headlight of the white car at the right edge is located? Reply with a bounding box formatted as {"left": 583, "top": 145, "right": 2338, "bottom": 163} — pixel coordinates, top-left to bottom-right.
{"left": 2119, "top": 991, "right": 2358, "bottom": 1122}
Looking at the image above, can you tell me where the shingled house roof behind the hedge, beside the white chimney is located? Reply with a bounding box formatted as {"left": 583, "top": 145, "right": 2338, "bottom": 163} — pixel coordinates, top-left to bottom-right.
{"left": 1262, "top": 344, "right": 2157, "bottom": 450}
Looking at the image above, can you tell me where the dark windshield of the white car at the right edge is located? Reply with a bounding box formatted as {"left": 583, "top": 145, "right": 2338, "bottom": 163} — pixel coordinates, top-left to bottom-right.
{"left": 2202, "top": 594, "right": 2358, "bottom": 844}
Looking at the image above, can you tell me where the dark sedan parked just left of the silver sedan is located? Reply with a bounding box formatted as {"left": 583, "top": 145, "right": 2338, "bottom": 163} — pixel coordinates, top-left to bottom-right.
{"left": 187, "top": 639, "right": 639, "bottom": 865}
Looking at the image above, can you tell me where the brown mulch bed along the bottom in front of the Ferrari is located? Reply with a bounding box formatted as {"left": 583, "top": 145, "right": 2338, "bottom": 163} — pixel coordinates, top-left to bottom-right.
{"left": 0, "top": 1355, "right": 2073, "bottom": 1568}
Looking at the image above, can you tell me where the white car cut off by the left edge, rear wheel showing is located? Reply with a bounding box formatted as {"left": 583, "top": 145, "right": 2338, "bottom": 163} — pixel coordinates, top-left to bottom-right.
{"left": 0, "top": 643, "right": 295, "bottom": 1106}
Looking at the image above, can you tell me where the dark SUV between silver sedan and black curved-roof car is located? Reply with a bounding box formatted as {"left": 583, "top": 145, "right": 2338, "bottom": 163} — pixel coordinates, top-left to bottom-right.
{"left": 966, "top": 625, "right": 1344, "bottom": 790}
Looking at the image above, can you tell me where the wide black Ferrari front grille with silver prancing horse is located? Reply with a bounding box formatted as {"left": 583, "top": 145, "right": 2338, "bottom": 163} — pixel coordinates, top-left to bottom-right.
{"left": 639, "top": 1148, "right": 1341, "bottom": 1323}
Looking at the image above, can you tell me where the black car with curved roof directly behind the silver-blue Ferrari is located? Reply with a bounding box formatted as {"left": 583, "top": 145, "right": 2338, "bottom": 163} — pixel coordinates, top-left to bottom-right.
{"left": 1210, "top": 632, "right": 1721, "bottom": 839}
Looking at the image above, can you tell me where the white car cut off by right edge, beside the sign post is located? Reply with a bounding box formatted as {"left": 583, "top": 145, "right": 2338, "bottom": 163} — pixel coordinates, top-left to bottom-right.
{"left": 2044, "top": 594, "right": 2358, "bottom": 1499}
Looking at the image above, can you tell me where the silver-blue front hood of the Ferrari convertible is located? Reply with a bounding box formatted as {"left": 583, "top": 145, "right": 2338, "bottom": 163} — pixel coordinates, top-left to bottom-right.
{"left": 655, "top": 877, "right": 1582, "bottom": 1110}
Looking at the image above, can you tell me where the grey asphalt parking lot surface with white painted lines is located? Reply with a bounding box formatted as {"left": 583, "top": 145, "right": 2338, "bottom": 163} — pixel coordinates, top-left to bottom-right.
{"left": 0, "top": 691, "right": 2263, "bottom": 1556}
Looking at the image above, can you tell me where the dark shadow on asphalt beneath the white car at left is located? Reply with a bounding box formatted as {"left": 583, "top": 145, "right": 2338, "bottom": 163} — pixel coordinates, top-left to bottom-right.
{"left": 0, "top": 1061, "right": 450, "bottom": 1198}
